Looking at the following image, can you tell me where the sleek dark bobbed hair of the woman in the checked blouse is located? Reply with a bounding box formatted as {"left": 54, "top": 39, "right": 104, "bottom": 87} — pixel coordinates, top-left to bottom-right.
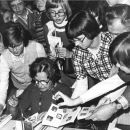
{"left": 66, "top": 11, "right": 100, "bottom": 40}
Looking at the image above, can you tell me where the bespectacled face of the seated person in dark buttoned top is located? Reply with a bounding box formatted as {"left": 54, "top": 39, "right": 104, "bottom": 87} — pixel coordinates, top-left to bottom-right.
{"left": 35, "top": 72, "right": 50, "bottom": 91}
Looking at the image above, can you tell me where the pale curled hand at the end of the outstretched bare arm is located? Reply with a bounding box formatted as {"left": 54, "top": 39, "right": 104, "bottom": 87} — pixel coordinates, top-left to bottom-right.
{"left": 53, "top": 92, "right": 74, "bottom": 107}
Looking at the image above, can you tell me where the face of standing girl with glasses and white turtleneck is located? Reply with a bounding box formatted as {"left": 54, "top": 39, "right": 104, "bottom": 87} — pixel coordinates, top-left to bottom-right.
{"left": 50, "top": 4, "right": 66, "bottom": 24}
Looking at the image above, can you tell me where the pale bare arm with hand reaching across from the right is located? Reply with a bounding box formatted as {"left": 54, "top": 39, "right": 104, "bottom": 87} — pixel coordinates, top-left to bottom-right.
{"left": 56, "top": 75, "right": 124, "bottom": 106}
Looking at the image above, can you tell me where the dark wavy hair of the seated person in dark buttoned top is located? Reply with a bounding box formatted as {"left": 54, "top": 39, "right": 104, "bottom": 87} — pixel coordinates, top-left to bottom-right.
{"left": 29, "top": 57, "right": 61, "bottom": 83}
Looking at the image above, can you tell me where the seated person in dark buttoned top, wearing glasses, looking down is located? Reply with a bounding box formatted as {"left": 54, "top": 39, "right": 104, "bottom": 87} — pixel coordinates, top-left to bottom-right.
{"left": 19, "top": 58, "right": 71, "bottom": 116}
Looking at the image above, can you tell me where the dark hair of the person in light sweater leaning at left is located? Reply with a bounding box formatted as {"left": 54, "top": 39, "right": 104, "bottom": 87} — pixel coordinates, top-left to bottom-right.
{"left": 3, "top": 22, "right": 28, "bottom": 48}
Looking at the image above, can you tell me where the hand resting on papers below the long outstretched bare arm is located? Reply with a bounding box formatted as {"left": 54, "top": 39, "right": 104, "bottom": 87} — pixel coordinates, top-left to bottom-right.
{"left": 87, "top": 103, "right": 118, "bottom": 121}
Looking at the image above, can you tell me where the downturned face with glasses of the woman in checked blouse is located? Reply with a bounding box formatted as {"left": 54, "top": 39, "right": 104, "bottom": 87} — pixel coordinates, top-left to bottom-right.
{"left": 73, "top": 35, "right": 92, "bottom": 49}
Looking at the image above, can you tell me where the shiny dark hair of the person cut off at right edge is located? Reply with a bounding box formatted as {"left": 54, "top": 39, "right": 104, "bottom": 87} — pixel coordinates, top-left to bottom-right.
{"left": 109, "top": 32, "right": 130, "bottom": 68}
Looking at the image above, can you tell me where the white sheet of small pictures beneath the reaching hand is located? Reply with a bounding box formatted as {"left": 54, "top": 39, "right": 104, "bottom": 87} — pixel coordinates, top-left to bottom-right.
{"left": 42, "top": 104, "right": 81, "bottom": 128}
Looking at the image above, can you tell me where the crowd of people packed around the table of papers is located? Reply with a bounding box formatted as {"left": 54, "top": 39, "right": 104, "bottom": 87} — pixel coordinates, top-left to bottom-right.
{"left": 0, "top": 0, "right": 130, "bottom": 130}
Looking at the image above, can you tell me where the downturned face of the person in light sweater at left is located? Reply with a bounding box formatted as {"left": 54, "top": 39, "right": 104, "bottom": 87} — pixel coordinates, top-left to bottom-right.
{"left": 8, "top": 42, "right": 24, "bottom": 56}
